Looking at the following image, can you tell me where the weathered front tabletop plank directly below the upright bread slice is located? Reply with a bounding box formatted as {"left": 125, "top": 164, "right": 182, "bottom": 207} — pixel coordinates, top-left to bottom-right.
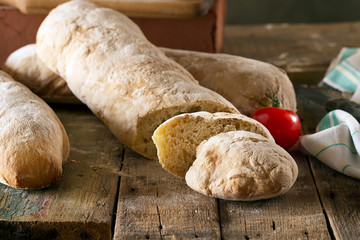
{"left": 114, "top": 149, "right": 220, "bottom": 239}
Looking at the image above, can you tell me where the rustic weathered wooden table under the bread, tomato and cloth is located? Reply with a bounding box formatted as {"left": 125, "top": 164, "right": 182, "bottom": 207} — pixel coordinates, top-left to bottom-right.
{"left": 0, "top": 23, "right": 360, "bottom": 240}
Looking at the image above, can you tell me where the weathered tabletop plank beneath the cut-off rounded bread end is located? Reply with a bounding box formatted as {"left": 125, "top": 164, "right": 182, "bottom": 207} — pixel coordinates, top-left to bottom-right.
{"left": 219, "top": 152, "right": 330, "bottom": 239}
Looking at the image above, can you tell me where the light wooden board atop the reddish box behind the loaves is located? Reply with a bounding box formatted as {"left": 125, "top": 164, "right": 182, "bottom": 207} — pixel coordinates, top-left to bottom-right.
{"left": 0, "top": 0, "right": 214, "bottom": 18}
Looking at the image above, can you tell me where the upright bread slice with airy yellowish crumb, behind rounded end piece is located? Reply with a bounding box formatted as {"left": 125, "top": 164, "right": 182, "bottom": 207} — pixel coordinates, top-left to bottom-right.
{"left": 152, "top": 112, "right": 274, "bottom": 178}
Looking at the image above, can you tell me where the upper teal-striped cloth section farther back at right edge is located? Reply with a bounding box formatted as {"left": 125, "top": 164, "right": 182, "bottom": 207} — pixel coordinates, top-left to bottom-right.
{"left": 320, "top": 48, "right": 360, "bottom": 103}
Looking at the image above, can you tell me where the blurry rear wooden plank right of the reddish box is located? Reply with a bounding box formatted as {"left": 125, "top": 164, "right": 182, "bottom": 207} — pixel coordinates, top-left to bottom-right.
{"left": 223, "top": 22, "right": 360, "bottom": 83}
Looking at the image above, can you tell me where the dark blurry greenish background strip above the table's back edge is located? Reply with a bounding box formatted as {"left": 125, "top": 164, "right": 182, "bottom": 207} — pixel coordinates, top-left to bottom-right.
{"left": 226, "top": 0, "right": 360, "bottom": 24}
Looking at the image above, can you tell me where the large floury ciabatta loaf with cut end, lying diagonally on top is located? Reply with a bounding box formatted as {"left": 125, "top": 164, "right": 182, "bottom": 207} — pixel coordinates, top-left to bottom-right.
{"left": 36, "top": 1, "right": 238, "bottom": 159}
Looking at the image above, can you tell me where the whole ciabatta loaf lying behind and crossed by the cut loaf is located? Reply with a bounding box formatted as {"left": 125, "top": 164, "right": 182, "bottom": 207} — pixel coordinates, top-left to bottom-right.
{"left": 3, "top": 44, "right": 296, "bottom": 115}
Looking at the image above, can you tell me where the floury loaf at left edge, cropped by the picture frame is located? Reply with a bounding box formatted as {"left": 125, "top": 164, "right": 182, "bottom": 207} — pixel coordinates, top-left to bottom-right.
{"left": 0, "top": 71, "right": 70, "bottom": 189}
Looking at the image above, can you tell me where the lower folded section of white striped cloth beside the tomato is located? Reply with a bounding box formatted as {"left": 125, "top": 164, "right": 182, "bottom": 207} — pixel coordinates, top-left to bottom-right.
{"left": 300, "top": 110, "right": 360, "bottom": 179}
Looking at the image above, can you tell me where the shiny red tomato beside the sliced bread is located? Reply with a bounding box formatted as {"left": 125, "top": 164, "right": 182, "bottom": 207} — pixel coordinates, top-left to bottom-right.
{"left": 251, "top": 107, "right": 301, "bottom": 149}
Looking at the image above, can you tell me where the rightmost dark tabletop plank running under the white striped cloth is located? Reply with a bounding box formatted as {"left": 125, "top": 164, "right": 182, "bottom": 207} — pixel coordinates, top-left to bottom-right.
{"left": 300, "top": 85, "right": 360, "bottom": 240}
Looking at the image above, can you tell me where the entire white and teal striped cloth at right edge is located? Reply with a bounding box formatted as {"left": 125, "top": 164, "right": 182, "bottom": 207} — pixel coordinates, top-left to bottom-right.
{"left": 300, "top": 48, "right": 360, "bottom": 179}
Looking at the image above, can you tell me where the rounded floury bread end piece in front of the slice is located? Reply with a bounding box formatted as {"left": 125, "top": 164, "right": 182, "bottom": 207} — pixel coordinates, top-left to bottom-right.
{"left": 185, "top": 131, "right": 298, "bottom": 201}
